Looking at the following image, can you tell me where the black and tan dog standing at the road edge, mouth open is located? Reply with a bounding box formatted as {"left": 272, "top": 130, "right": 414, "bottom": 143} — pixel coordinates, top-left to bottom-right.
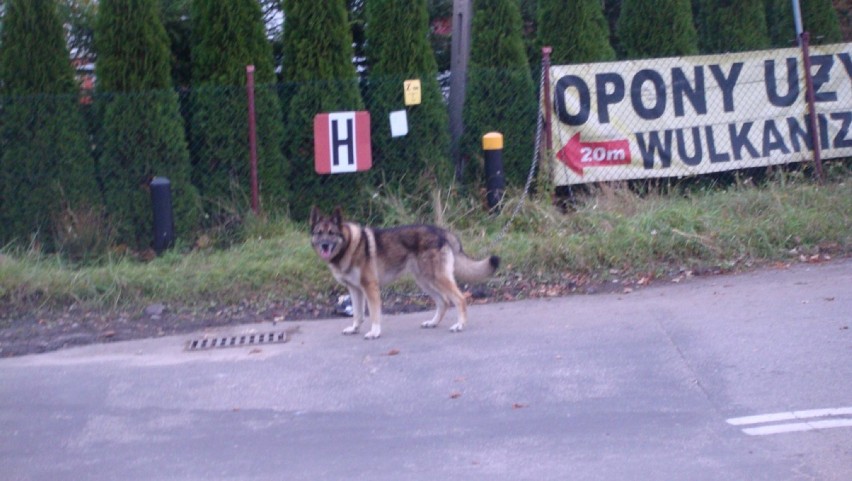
{"left": 310, "top": 206, "right": 500, "bottom": 339}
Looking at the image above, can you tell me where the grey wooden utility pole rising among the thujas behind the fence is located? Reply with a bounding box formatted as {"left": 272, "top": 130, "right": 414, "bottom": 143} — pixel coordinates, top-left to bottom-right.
{"left": 449, "top": 0, "right": 473, "bottom": 181}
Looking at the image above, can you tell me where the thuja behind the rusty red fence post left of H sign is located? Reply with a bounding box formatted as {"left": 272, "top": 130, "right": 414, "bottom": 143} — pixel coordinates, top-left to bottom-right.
{"left": 190, "top": 0, "right": 289, "bottom": 212}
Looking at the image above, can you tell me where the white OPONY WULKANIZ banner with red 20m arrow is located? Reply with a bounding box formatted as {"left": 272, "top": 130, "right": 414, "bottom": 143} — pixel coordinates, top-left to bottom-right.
{"left": 550, "top": 43, "right": 852, "bottom": 185}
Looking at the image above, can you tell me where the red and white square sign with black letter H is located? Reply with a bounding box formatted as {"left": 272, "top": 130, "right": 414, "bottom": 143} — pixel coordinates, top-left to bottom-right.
{"left": 314, "top": 112, "right": 373, "bottom": 174}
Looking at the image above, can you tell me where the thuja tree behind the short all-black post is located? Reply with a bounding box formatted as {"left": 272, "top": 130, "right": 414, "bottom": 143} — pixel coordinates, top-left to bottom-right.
{"left": 95, "top": 0, "right": 200, "bottom": 248}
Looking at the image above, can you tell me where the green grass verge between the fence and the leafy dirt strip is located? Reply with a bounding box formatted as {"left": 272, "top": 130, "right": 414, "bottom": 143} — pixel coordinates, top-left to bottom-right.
{"left": 0, "top": 164, "right": 852, "bottom": 309}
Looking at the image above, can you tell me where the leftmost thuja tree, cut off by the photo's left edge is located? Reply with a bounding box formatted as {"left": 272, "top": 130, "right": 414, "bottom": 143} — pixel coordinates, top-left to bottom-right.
{"left": 0, "top": 0, "right": 100, "bottom": 244}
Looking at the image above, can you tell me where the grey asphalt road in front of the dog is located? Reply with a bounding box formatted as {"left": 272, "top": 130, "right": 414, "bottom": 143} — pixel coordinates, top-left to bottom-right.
{"left": 0, "top": 260, "right": 852, "bottom": 481}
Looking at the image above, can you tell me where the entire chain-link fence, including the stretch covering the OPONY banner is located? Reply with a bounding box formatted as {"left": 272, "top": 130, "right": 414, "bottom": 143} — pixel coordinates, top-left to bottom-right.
{"left": 0, "top": 44, "right": 852, "bottom": 250}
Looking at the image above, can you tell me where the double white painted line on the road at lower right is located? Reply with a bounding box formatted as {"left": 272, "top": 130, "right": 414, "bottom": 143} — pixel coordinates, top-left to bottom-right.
{"left": 727, "top": 407, "right": 852, "bottom": 436}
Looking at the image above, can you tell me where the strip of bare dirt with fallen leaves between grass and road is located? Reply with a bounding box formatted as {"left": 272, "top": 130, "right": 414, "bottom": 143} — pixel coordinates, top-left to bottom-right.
{"left": 0, "top": 259, "right": 840, "bottom": 357}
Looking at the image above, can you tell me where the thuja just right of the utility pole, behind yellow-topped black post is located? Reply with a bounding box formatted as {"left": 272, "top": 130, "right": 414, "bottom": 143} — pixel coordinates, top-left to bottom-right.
{"left": 462, "top": 0, "right": 536, "bottom": 186}
